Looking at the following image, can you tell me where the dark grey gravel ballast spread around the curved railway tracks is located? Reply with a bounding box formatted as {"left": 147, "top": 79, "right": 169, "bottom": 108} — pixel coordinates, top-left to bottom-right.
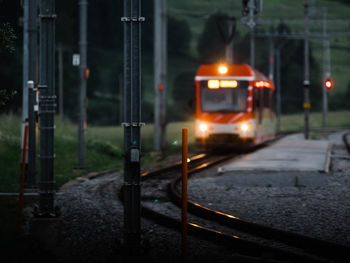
{"left": 18, "top": 131, "right": 350, "bottom": 262}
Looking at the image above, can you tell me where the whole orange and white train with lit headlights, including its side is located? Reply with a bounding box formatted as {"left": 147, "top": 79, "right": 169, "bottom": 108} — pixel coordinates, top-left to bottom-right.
{"left": 194, "top": 64, "right": 276, "bottom": 150}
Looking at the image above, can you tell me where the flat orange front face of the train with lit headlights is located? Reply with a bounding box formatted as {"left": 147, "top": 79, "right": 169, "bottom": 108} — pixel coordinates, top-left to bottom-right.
{"left": 195, "top": 65, "right": 255, "bottom": 148}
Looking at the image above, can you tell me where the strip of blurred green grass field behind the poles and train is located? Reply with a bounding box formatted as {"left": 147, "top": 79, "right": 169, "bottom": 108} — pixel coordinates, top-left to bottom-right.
{"left": 0, "top": 111, "right": 350, "bottom": 192}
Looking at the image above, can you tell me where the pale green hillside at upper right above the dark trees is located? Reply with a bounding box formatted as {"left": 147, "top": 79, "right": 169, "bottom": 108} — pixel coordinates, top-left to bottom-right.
{"left": 168, "top": 0, "right": 350, "bottom": 95}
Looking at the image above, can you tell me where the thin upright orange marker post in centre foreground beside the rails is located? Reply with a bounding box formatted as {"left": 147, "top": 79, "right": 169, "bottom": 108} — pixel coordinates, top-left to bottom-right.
{"left": 181, "top": 128, "right": 188, "bottom": 263}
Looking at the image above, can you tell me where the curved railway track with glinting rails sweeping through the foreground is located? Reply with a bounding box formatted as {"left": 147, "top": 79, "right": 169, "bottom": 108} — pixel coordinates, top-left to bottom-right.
{"left": 126, "top": 147, "right": 349, "bottom": 262}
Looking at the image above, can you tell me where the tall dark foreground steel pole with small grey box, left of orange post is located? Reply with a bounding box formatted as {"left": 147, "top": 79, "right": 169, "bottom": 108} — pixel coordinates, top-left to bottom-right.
{"left": 121, "top": 0, "right": 145, "bottom": 262}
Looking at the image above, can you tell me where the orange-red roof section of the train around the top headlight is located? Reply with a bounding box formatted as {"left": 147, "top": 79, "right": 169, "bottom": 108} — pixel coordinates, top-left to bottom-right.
{"left": 195, "top": 64, "right": 267, "bottom": 80}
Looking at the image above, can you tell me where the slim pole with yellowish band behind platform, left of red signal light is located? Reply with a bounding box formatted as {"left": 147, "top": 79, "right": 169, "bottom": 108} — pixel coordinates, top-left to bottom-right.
{"left": 303, "top": 0, "right": 310, "bottom": 140}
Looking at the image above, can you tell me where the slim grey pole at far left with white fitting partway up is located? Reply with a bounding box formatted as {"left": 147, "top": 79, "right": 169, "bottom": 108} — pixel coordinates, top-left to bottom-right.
{"left": 25, "top": 0, "right": 38, "bottom": 188}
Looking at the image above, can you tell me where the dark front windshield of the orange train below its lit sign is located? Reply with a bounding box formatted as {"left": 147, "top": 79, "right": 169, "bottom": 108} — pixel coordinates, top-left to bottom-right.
{"left": 201, "top": 81, "right": 248, "bottom": 112}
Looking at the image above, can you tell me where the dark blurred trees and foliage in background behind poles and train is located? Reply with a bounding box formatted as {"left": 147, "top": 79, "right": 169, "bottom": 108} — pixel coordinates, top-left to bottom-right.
{"left": 0, "top": 0, "right": 350, "bottom": 125}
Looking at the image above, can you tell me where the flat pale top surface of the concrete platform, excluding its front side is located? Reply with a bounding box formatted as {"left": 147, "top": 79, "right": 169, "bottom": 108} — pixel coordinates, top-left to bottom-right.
{"left": 218, "top": 134, "right": 332, "bottom": 173}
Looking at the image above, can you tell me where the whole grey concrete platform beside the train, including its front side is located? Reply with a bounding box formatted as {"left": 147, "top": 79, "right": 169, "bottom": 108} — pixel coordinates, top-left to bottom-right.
{"left": 216, "top": 134, "right": 333, "bottom": 187}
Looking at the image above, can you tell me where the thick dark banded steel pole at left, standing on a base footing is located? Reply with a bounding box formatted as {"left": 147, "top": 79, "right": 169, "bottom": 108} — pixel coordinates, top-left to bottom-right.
{"left": 37, "top": 0, "right": 56, "bottom": 217}
